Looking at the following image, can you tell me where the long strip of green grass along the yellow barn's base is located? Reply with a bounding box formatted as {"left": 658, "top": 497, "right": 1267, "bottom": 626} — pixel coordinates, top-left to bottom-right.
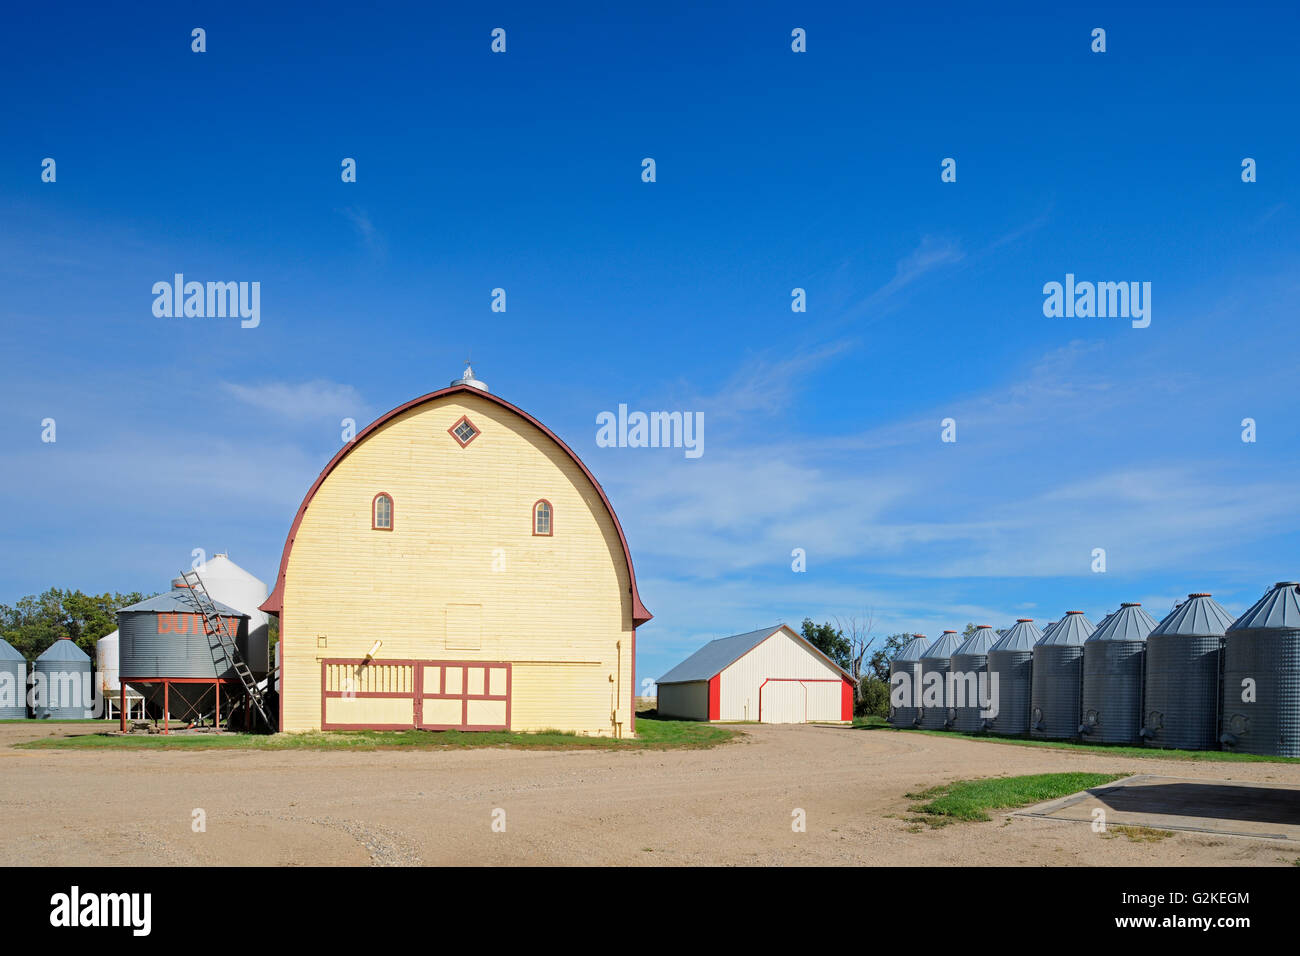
{"left": 14, "top": 714, "right": 740, "bottom": 750}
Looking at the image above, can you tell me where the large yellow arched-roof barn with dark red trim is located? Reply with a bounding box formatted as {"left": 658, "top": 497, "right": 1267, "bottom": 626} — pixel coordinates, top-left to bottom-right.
{"left": 261, "top": 368, "right": 650, "bottom": 736}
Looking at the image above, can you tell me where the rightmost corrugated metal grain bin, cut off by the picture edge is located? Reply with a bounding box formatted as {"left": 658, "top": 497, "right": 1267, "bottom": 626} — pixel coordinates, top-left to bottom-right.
{"left": 1219, "top": 581, "right": 1300, "bottom": 757}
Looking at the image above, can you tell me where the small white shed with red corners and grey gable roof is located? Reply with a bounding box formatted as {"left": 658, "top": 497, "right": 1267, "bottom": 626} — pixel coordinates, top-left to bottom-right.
{"left": 658, "top": 624, "right": 853, "bottom": 723}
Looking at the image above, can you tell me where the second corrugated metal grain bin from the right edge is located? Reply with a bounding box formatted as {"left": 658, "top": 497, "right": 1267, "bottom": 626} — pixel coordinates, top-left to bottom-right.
{"left": 1141, "top": 593, "right": 1232, "bottom": 750}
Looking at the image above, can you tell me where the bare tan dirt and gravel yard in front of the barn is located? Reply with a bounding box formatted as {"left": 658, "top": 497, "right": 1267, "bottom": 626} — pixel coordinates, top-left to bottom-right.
{"left": 0, "top": 724, "right": 1300, "bottom": 866}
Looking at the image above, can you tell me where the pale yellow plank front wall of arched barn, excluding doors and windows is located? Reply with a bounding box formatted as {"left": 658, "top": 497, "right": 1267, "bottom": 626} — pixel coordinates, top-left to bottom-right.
{"left": 282, "top": 393, "right": 633, "bottom": 735}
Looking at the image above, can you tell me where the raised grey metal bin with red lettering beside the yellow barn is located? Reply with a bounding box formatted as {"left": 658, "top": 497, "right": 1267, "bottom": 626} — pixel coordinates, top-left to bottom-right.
{"left": 117, "top": 588, "right": 261, "bottom": 713}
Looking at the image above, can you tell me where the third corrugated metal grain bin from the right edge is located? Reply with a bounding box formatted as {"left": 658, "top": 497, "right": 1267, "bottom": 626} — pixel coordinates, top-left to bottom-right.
{"left": 1079, "top": 601, "right": 1156, "bottom": 744}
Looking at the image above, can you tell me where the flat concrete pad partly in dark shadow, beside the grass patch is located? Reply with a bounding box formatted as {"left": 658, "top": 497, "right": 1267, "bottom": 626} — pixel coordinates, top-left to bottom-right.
{"left": 1008, "top": 774, "right": 1300, "bottom": 842}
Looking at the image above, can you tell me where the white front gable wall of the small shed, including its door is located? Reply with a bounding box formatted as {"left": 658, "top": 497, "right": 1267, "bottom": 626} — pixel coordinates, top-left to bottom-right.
{"left": 722, "top": 631, "right": 844, "bottom": 723}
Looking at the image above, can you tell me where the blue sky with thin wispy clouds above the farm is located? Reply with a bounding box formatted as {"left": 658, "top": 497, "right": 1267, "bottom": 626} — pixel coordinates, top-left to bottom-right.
{"left": 0, "top": 4, "right": 1300, "bottom": 676}
